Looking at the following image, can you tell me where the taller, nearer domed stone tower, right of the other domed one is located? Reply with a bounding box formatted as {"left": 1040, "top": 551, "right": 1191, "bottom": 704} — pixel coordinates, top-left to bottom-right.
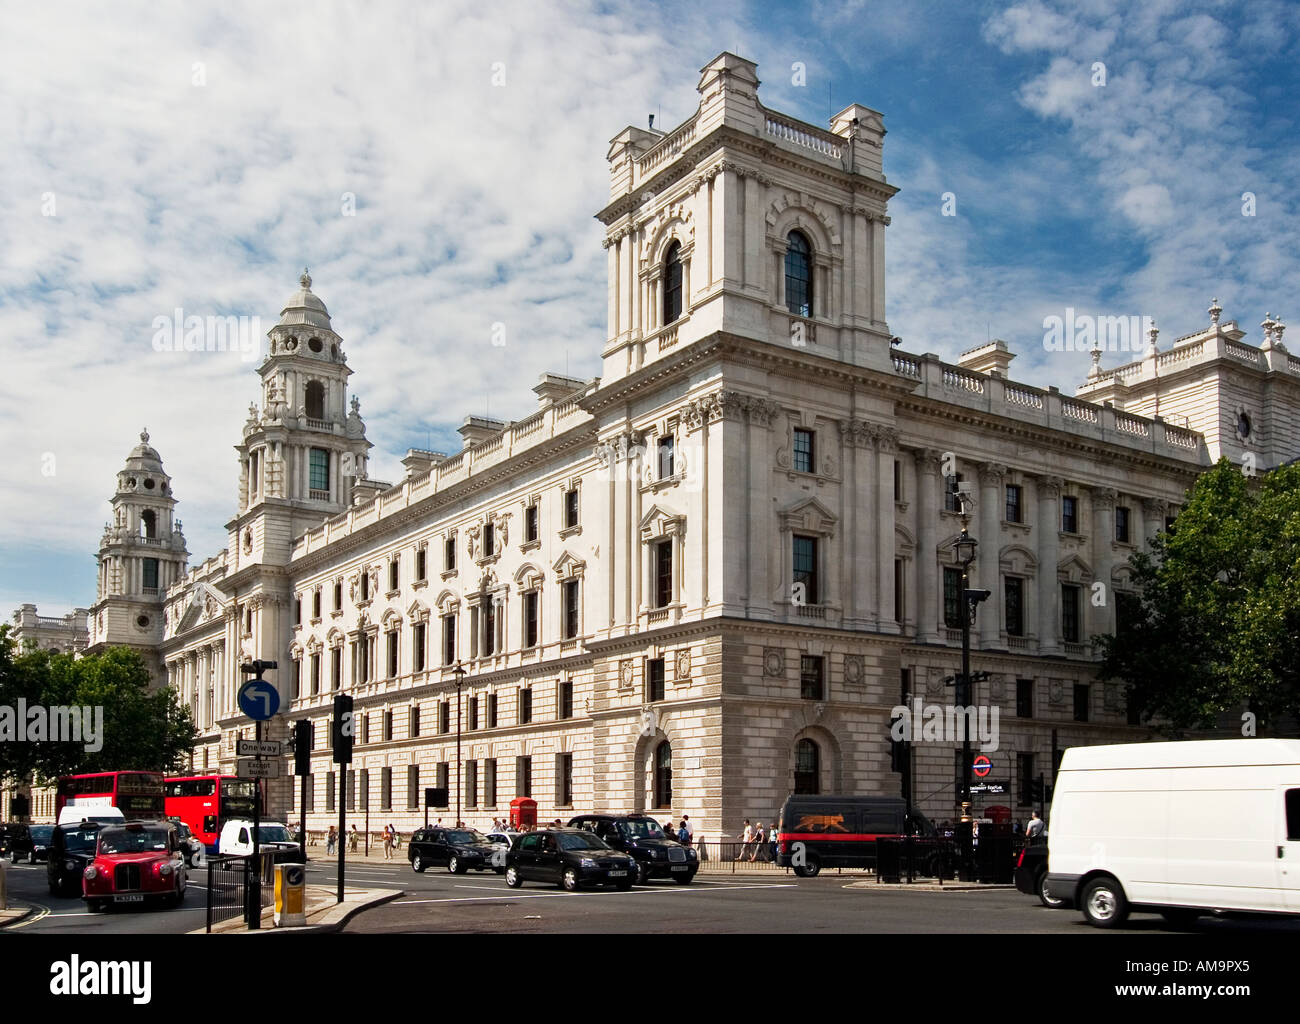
{"left": 228, "top": 270, "right": 372, "bottom": 565}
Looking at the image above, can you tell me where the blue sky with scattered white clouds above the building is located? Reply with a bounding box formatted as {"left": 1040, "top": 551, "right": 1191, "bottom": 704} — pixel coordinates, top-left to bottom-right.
{"left": 0, "top": 0, "right": 1300, "bottom": 615}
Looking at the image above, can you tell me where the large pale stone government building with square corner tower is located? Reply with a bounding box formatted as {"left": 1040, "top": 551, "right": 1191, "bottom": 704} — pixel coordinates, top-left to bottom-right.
{"left": 81, "top": 53, "right": 1300, "bottom": 837}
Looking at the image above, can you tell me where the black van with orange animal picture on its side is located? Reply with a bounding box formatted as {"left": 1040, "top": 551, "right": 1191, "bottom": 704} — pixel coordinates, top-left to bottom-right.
{"left": 776, "top": 795, "right": 935, "bottom": 878}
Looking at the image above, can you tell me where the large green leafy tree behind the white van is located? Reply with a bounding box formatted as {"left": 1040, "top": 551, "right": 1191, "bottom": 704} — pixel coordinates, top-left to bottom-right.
{"left": 1096, "top": 459, "right": 1300, "bottom": 732}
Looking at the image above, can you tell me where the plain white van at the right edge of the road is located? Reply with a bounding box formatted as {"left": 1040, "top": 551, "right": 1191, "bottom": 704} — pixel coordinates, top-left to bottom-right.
{"left": 1047, "top": 739, "right": 1300, "bottom": 928}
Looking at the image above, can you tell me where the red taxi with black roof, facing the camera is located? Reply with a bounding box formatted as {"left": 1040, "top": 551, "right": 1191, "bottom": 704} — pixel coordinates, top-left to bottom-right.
{"left": 82, "top": 820, "right": 186, "bottom": 911}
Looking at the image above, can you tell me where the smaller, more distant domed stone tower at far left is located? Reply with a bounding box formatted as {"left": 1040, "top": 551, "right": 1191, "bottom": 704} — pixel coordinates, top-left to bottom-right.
{"left": 87, "top": 430, "right": 190, "bottom": 684}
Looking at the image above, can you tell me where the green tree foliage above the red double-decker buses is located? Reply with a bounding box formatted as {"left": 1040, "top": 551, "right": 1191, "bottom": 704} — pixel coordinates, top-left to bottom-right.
{"left": 0, "top": 626, "right": 198, "bottom": 784}
